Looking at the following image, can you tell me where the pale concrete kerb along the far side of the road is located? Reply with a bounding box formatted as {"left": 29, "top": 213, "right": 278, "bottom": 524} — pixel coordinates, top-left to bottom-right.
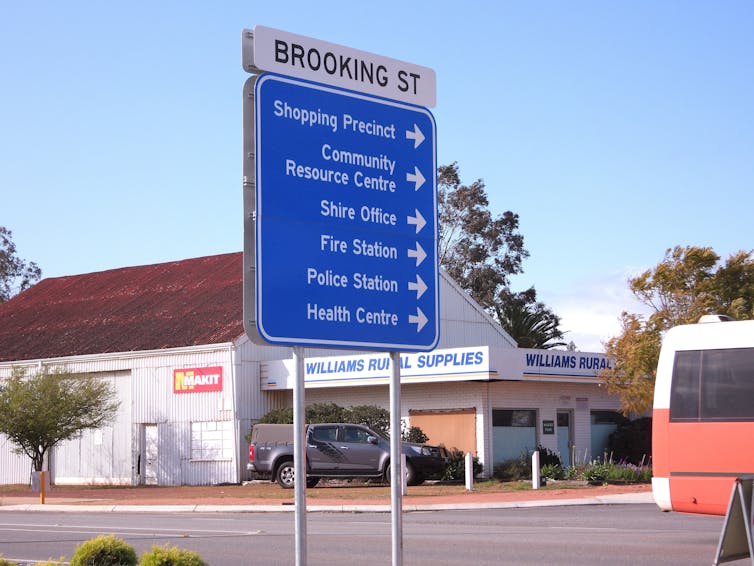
{"left": 0, "top": 492, "right": 654, "bottom": 513}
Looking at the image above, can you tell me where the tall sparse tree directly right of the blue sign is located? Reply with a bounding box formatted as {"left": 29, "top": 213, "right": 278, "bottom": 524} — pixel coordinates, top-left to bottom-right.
{"left": 437, "top": 163, "right": 529, "bottom": 309}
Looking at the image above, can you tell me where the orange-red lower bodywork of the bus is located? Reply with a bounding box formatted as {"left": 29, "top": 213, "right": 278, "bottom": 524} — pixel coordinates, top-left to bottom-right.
{"left": 667, "top": 422, "right": 754, "bottom": 515}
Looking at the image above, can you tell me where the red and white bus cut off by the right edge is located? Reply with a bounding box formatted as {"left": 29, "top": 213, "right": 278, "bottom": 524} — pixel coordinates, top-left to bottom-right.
{"left": 652, "top": 316, "right": 754, "bottom": 515}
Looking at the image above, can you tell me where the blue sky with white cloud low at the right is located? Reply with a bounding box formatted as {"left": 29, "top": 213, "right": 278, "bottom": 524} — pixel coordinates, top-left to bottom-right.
{"left": 0, "top": 0, "right": 754, "bottom": 351}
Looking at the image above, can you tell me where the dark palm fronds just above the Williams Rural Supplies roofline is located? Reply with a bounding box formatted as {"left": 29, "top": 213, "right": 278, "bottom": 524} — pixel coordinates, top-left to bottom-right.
{"left": 494, "top": 287, "right": 566, "bottom": 350}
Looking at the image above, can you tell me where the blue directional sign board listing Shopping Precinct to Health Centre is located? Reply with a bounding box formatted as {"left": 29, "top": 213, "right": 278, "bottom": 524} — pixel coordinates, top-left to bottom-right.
{"left": 254, "top": 73, "right": 440, "bottom": 351}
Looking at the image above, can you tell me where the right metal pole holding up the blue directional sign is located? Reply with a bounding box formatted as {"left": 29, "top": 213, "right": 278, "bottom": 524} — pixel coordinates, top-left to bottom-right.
{"left": 390, "top": 352, "right": 403, "bottom": 566}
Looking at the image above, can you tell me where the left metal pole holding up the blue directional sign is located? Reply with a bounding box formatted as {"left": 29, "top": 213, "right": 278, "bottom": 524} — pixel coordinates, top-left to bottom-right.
{"left": 293, "top": 346, "right": 306, "bottom": 566}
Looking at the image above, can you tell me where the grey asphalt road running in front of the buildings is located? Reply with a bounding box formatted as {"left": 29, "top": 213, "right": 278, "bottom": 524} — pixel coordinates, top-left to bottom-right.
{"left": 0, "top": 504, "right": 728, "bottom": 566}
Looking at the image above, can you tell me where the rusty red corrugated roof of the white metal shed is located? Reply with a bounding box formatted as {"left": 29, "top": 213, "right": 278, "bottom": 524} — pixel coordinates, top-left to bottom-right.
{"left": 0, "top": 252, "right": 244, "bottom": 361}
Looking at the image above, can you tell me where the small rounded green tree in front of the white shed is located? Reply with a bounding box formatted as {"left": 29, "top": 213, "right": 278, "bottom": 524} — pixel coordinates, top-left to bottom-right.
{"left": 0, "top": 368, "right": 120, "bottom": 472}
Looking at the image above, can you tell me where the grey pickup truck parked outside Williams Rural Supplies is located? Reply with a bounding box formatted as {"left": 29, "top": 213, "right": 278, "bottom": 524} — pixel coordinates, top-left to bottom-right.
{"left": 246, "top": 423, "right": 448, "bottom": 488}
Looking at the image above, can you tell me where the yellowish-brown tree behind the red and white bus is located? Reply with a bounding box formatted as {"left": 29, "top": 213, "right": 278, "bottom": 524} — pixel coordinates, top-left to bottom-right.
{"left": 602, "top": 246, "right": 754, "bottom": 414}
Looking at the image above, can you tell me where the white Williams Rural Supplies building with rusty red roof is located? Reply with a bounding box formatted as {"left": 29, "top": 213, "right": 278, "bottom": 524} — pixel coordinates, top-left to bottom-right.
{"left": 0, "top": 253, "right": 619, "bottom": 485}
